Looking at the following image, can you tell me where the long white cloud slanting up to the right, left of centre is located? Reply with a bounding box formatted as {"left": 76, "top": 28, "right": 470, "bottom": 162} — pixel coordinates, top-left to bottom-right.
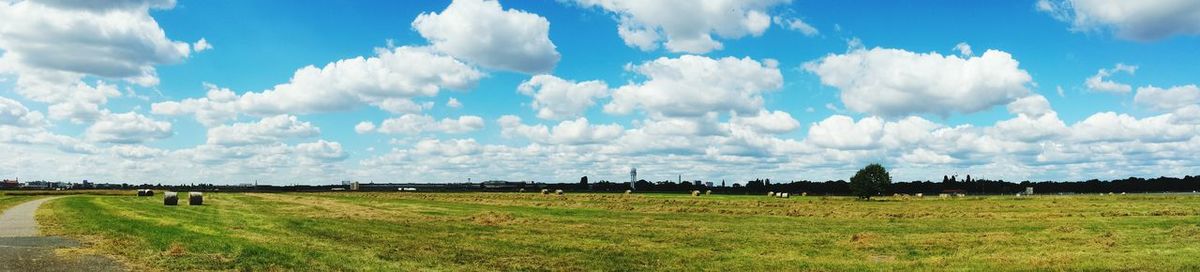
{"left": 151, "top": 47, "right": 484, "bottom": 119}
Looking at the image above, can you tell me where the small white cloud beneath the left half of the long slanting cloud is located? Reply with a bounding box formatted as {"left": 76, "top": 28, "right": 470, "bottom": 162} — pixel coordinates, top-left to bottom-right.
{"left": 208, "top": 114, "right": 320, "bottom": 146}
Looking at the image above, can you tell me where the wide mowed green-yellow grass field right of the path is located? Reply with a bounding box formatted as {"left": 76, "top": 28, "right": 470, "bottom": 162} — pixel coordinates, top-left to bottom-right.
{"left": 38, "top": 193, "right": 1200, "bottom": 271}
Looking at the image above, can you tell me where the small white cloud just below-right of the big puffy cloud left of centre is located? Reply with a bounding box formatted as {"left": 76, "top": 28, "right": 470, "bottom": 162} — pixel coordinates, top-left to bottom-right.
{"left": 517, "top": 74, "right": 608, "bottom": 120}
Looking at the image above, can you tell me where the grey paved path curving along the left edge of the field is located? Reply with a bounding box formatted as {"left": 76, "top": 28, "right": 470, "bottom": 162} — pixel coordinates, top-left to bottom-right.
{"left": 0, "top": 198, "right": 124, "bottom": 271}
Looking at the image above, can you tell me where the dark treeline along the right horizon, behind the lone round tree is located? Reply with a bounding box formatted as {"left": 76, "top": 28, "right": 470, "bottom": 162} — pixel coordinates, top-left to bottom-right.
{"left": 559, "top": 176, "right": 1200, "bottom": 195}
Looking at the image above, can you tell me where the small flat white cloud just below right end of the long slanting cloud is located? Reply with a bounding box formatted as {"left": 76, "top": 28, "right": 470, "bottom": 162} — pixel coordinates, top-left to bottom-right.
{"left": 377, "top": 114, "right": 484, "bottom": 134}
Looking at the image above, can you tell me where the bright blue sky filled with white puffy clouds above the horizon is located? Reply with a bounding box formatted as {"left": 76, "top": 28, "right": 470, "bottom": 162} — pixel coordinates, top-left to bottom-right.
{"left": 0, "top": 0, "right": 1200, "bottom": 185}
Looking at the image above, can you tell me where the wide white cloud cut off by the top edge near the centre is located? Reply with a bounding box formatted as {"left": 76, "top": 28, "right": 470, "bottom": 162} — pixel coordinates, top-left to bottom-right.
{"left": 576, "top": 0, "right": 790, "bottom": 54}
